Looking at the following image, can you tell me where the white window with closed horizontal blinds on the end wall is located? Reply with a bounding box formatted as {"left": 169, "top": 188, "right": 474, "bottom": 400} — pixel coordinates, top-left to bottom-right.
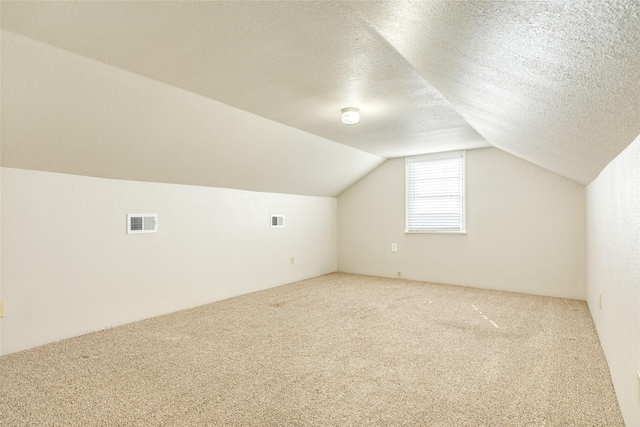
{"left": 405, "top": 151, "right": 466, "bottom": 233}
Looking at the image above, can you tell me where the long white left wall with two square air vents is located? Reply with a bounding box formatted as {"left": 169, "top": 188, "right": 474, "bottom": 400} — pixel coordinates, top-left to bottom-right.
{"left": 1, "top": 168, "right": 336, "bottom": 354}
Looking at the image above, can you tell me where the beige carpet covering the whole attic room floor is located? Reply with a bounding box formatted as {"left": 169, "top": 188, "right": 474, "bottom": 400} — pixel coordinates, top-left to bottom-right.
{"left": 0, "top": 273, "right": 624, "bottom": 426}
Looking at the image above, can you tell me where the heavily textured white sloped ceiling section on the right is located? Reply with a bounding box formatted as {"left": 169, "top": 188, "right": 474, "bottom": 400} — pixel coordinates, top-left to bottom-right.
{"left": 353, "top": 0, "right": 640, "bottom": 184}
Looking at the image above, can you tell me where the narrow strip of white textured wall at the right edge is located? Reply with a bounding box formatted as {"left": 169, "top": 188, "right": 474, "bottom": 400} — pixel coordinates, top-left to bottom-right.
{"left": 587, "top": 137, "right": 640, "bottom": 426}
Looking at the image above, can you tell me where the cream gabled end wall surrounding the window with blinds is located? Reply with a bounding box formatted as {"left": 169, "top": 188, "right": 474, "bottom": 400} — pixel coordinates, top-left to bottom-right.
{"left": 338, "top": 148, "right": 586, "bottom": 299}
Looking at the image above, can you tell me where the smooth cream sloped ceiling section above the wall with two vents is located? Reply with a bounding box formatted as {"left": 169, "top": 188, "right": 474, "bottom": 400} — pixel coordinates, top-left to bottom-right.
{"left": 2, "top": 30, "right": 383, "bottom": 196}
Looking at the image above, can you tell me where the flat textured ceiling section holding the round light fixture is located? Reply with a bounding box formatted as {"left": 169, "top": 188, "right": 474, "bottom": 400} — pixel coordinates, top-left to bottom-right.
{"left": 2, "top": 1, "right": 488, "bottom": 157}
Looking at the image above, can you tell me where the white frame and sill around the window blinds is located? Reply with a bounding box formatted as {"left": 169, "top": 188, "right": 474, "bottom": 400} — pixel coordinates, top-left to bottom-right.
{"left": 404, "top": 150, "right": 467, "bottom": 234}
